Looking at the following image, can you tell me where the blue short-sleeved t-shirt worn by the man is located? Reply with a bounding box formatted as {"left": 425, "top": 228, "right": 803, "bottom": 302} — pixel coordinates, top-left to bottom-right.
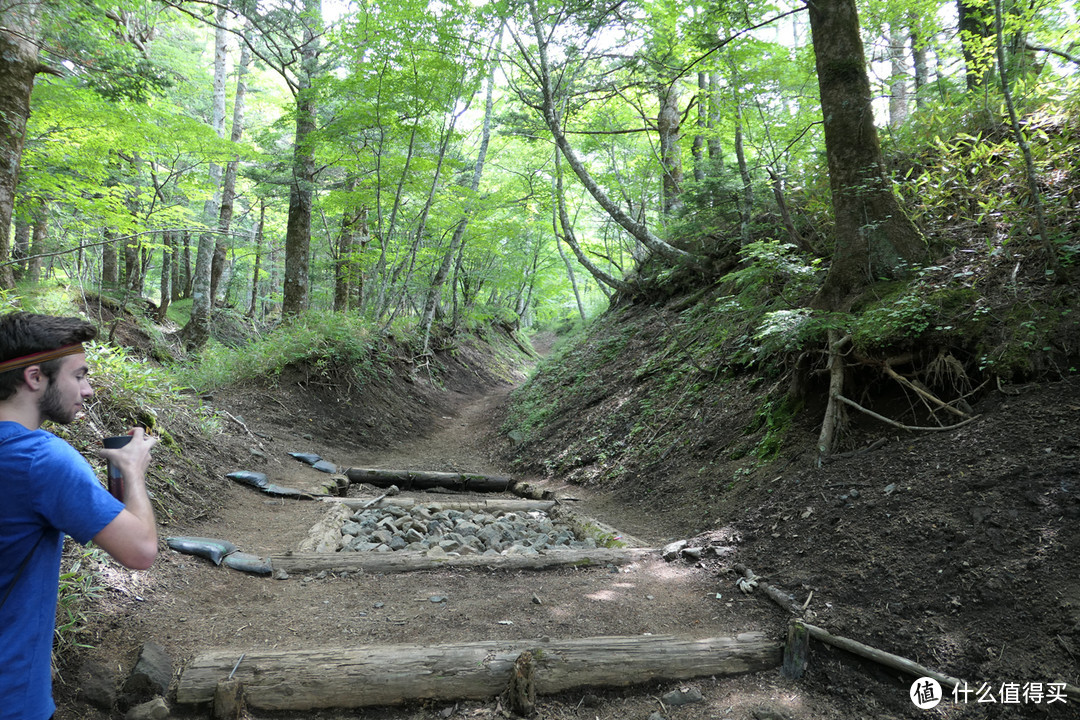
{"left": 0, "top": 422, "right": 124, "bottom": 720}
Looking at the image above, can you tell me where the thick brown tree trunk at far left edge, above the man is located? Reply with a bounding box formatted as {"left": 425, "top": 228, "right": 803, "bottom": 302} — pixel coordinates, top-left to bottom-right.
{"left": 0, "top": 0, "right": 43, "bottom": 289}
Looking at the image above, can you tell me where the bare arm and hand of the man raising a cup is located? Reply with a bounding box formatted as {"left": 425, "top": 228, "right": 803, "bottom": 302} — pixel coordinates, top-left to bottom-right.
{"left": 94, "top": 427, "right": 158, "bottom": 570}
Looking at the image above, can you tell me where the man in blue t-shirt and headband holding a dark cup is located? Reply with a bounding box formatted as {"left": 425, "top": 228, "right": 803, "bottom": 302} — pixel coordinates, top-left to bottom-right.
{"left": 0, "top": 312, "right": 158, "bottom": 720}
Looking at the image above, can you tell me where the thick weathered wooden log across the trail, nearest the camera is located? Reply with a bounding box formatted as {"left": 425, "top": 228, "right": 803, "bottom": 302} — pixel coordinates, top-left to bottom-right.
{"left": 176, "top": 633, "right": 782, "bottom": 710}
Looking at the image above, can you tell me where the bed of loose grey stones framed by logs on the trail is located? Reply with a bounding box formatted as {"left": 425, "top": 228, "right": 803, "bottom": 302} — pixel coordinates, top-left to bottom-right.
{"left": 341, "top": 505, "right": 596, "bottom": 557}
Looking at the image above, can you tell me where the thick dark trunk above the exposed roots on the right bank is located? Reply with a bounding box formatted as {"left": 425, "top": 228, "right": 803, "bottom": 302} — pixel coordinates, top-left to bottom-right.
{"left": 809, "top": 0, "right": 924, "bottom": 310}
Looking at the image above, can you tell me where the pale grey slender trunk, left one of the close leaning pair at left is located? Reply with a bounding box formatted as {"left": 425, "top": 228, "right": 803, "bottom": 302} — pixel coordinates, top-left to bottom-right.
{"left": 181, "top": 5, "right": 228, "bottom": 349}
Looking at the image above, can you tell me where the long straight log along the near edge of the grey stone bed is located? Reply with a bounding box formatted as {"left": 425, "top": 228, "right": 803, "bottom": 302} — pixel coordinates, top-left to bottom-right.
{"left": 270, "top": 547, "right": 656, "bottom": 575}
